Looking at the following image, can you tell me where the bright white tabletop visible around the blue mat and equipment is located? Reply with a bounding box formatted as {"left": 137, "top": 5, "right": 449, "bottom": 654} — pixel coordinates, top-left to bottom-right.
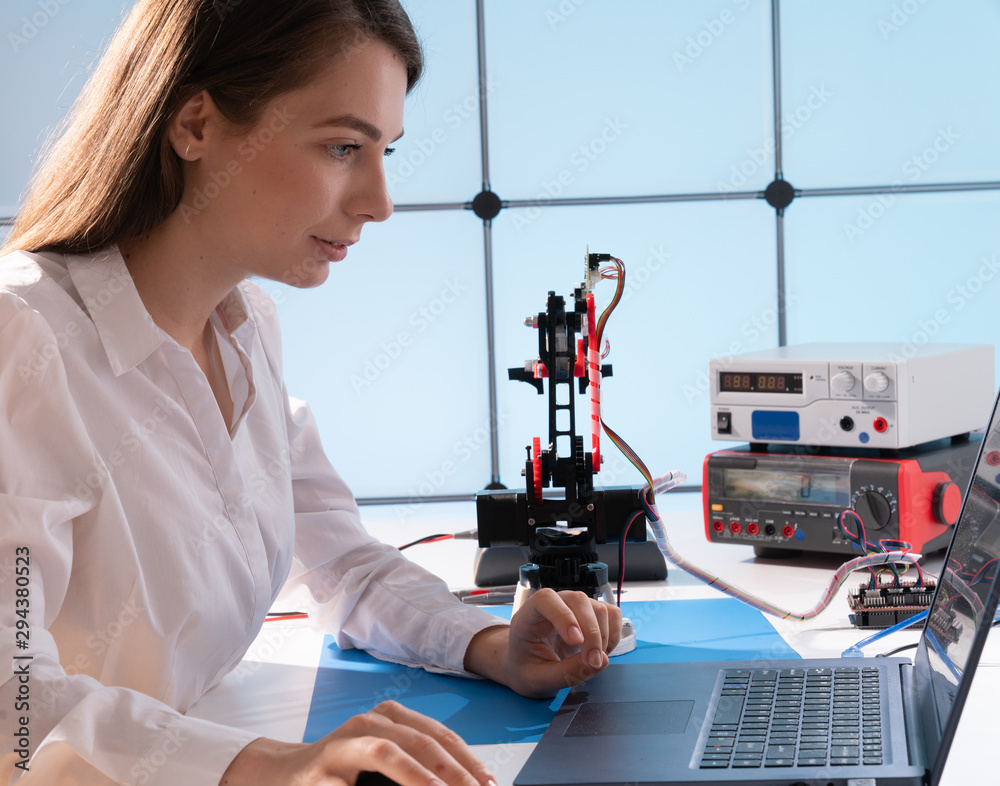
{"left": 189, "top": 494, "right": 1000, "bottom": 786}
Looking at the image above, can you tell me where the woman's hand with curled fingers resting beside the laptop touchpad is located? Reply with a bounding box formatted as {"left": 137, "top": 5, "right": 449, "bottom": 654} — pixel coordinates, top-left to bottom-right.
{"left": 465, "top": 589, "right": 622, "bottom": 697}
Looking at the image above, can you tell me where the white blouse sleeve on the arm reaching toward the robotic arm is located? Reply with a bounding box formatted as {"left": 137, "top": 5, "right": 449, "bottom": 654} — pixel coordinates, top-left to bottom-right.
{"left": 278, "top": 399, "right": 507, "bottom": 676}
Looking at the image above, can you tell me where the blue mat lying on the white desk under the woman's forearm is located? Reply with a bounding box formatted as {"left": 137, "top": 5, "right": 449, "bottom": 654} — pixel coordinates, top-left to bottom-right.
{"left": 303, "top": 598, "right": 799, "bottom": 745}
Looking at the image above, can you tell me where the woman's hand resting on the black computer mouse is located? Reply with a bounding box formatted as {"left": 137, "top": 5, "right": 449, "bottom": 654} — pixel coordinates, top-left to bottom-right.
{"left": 219, "top": 701, "right": 496, "bottom": 786}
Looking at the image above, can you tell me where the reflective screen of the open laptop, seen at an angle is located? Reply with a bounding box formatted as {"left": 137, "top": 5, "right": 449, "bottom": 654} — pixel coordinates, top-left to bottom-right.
{"left": 917, "top": 396, "right": 1000, "bottom": 772}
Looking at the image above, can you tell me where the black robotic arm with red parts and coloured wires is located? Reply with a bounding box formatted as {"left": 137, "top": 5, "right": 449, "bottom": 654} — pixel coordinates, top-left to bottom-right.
{"left": 476, "top": 253, "right": 666, "bottom": 595}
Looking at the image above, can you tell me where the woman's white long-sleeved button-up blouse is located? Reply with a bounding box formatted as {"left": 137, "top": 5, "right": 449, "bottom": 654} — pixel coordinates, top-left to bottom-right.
{"left": 0, "top": 248, "right": 498, "bottom": 786}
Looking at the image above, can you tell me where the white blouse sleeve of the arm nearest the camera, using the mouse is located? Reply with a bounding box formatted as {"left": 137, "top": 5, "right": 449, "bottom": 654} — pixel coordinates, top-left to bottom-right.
{"left": 0, "top": 293, "right": 257, "bottom": 786}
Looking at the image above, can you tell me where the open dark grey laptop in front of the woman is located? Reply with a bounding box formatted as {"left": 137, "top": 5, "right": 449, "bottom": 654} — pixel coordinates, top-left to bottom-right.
{"left": 514, "top": 388, "right": 1000, "bottom": 786}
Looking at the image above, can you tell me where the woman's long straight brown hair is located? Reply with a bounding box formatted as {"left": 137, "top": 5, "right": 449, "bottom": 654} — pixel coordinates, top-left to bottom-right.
{"left": 0, "top": 0, "right": 423, "bottom": 254}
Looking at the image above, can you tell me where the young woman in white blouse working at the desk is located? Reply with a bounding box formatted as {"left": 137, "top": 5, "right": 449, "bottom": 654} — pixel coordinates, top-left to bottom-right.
{"left": 0, "top": 0, "right": 620, "bottom": 786}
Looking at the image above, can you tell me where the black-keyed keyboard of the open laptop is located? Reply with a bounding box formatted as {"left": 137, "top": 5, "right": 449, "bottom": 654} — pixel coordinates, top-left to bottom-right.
{"left": 701, "top": 666, "right": 882, "bottom": 769}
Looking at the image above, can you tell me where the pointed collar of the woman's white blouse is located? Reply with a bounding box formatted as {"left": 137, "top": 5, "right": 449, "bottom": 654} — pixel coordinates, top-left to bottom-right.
{"left": 66, "top": 246, "right": 250, "bottom": 377}
